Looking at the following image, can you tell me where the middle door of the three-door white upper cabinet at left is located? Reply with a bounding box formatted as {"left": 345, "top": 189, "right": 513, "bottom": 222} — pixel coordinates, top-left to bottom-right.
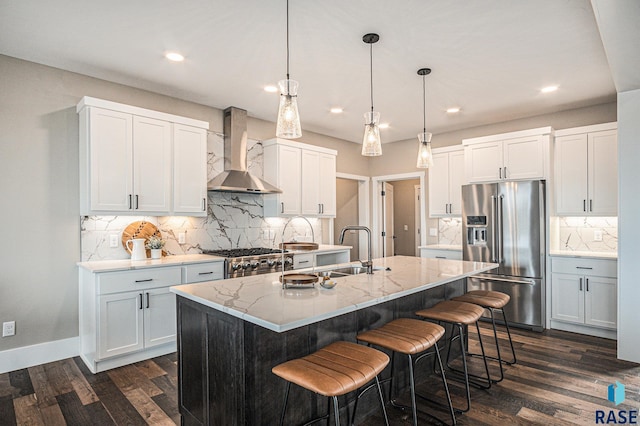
{"left": 133, "top": 116, "right": 172, "bottom": 213}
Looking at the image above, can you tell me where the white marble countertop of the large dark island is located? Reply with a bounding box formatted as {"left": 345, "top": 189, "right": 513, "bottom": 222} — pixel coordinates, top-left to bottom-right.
{"left": 171, "top": 256, "right": 497, "bottom": 332}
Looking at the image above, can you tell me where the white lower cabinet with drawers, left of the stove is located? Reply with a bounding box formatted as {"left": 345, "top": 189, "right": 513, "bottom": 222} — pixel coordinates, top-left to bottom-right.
{"left": 79, "top": 261, "right": 224, "bottom": 373}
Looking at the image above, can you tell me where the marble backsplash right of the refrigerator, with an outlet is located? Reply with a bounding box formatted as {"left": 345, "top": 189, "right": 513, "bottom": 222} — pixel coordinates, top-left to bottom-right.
{"left": 557, "top": 217, "right": 618, "bottom": 253}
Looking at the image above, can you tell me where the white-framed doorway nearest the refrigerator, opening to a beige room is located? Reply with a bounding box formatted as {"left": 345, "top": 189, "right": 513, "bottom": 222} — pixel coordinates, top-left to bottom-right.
{"left": 372, "top": 172, "right": 426, "bottom": 257}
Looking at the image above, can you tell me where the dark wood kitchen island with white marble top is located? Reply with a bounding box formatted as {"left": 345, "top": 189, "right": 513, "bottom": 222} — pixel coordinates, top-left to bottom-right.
{"left": 171, "top": 256, "right": 496, "bottom": 425}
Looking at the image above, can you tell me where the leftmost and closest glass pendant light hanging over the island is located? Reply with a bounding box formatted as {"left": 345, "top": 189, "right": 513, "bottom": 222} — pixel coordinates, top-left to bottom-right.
{"left": 276, "top": 0, "right": 302, "bottom": 139}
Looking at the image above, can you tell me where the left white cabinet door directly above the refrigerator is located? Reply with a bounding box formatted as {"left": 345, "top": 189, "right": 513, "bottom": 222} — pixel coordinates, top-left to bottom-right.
{"left": 464, "top": 141, "right": 503, "bottom": 183}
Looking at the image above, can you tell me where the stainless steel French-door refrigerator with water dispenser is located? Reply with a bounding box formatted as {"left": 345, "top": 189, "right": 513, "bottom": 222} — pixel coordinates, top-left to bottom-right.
{"left": 462, "top": 180, "right": 546, "bottom": 331}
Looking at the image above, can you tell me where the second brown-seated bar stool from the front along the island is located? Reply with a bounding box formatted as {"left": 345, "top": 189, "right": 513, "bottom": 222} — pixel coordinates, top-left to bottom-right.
{"left": 354, "top": 318, "right": 456, "bottom": 425}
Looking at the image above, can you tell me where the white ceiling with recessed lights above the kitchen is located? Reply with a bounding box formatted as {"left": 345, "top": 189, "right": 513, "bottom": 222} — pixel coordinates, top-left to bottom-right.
{"left": 0, "top": 0, "right": 620, "bottom": 142}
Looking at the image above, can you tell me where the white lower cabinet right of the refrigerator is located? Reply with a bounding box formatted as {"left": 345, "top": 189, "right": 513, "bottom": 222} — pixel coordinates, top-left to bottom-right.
{"left": 551, "top": 257, "right": 618, "bottom": 335}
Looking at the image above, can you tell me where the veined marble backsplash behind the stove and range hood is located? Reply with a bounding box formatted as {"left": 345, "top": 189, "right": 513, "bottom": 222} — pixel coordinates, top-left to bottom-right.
{"left": 80, "top": 133, "right": 322, "bottom": 261}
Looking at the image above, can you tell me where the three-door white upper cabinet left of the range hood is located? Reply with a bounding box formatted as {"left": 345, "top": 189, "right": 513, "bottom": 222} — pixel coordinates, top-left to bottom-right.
{"left": 77, "top": 96, "right": 209, "bottom": 216}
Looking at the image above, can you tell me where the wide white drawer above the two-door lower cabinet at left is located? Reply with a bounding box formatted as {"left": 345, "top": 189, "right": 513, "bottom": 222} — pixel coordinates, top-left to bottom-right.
{"left": 97, "top": 267, "right": 182, "bottom": 294}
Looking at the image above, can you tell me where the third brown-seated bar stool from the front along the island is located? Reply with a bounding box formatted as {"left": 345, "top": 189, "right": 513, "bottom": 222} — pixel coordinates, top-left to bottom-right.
{"left": 416, "top": 300, "right": 491, "bottom": 413}
